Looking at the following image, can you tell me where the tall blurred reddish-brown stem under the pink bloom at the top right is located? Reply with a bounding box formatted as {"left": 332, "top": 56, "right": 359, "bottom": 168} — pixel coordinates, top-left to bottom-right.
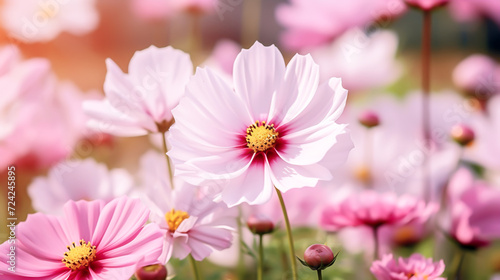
{"left": 422, "top": 10, "right": 431, "bottom": 201}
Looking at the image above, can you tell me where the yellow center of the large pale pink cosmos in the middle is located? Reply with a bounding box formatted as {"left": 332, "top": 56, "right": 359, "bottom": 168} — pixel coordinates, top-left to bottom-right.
{"left": 246, "top": 121, "right": 279, "bottom": 153}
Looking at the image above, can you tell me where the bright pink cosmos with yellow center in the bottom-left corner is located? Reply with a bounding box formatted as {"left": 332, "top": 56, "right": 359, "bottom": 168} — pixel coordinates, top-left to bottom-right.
{"left": 0, "top": 197, "right": 162, "bottom": 280}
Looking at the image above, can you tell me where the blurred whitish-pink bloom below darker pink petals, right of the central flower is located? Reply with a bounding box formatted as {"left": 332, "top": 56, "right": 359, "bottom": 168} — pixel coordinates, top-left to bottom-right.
{"left": 311, "top": 28, "right": 401, "bottom": 93}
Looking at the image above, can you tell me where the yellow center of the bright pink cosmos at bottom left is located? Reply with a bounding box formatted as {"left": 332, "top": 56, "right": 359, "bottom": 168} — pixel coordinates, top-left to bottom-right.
{"left": 62, "top": 239, "right": 96, "bottom": 271}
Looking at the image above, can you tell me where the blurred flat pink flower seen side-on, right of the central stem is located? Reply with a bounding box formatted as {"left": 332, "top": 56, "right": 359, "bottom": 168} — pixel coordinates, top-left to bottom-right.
{"left": 320, "top": 191, "right": 436, "bottom": 231}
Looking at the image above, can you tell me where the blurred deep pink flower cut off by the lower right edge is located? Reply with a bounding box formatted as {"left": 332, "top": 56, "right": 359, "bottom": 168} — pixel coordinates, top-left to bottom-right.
{"left": 448, "top": 168, "right": 500, "bottom": 248}
